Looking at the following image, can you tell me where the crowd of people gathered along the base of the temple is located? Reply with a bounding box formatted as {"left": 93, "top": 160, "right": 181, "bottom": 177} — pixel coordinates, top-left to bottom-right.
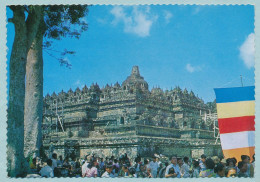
{"left": 27, "top": 153, "right": 255, "bottom": 178}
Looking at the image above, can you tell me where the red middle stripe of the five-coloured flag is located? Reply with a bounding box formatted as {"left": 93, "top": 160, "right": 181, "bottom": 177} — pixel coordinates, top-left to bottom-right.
{"left": 218, "top": 116, "right": 255, "bottom": 134}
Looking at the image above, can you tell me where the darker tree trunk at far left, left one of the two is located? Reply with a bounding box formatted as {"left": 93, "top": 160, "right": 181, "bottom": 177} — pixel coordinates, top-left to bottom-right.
{"left": 7, "top": 7, "right": 27, "bottom": 177}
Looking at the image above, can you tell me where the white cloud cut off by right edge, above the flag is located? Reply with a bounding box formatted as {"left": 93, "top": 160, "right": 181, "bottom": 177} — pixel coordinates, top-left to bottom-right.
{"left": 239, "top": 33, "right": 255, "bottom": 69}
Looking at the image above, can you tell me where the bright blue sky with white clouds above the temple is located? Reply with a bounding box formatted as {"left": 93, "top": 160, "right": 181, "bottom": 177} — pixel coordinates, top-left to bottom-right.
{"left": 7, "top": 5, "right": 254, "bottom": 102}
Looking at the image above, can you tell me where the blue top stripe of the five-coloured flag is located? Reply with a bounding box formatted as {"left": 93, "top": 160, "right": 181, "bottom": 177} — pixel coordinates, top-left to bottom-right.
{"left": 214, "top": 86, "right": 255, "bottom": 103}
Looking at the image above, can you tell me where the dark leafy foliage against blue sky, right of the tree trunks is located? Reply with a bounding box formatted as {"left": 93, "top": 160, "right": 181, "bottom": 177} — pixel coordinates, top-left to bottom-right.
{"left": 42, "top": 5, "right": 88, "bottom": 68}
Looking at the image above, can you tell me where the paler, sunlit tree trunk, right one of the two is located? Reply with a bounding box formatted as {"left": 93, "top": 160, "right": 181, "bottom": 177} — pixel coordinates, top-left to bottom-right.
{"left": 24, "top": 31, "right": 43, "bottom": 157}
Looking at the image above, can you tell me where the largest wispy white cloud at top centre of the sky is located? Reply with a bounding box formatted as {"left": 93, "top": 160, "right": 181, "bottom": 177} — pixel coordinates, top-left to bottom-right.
{"left": 110, "top": 6, "right": 157, "bottom": 37}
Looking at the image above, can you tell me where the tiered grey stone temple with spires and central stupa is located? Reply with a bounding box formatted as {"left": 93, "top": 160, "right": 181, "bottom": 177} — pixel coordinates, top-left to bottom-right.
{"left": 42, "top": 66, "right": 222, "bottom": 158}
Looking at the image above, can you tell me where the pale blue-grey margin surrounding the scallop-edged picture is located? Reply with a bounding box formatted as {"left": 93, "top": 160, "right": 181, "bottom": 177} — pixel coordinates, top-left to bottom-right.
{"left": 0, "top": 0, "right": 260, "bottom": 182}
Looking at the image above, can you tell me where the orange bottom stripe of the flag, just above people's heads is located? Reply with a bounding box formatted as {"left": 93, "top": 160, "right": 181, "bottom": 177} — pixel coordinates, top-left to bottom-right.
{"left": 223, "top": 147, "right": 255, "bottom": 161}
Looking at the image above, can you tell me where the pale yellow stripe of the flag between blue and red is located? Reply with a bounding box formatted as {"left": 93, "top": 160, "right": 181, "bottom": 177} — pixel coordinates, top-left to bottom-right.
{"left": 217, "top": 101, "right": 255, "bottom": 119}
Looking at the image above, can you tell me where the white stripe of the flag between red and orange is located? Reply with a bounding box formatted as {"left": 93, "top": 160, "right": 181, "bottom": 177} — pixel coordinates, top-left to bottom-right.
{"left": 220, "top": 131, "right": 255, "bottom": 150}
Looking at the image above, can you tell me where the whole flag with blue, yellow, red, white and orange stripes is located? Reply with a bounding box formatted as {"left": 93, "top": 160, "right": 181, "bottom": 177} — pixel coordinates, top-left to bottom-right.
{"left": 214, "top": 86, "right": 255, "bottom": 161}
